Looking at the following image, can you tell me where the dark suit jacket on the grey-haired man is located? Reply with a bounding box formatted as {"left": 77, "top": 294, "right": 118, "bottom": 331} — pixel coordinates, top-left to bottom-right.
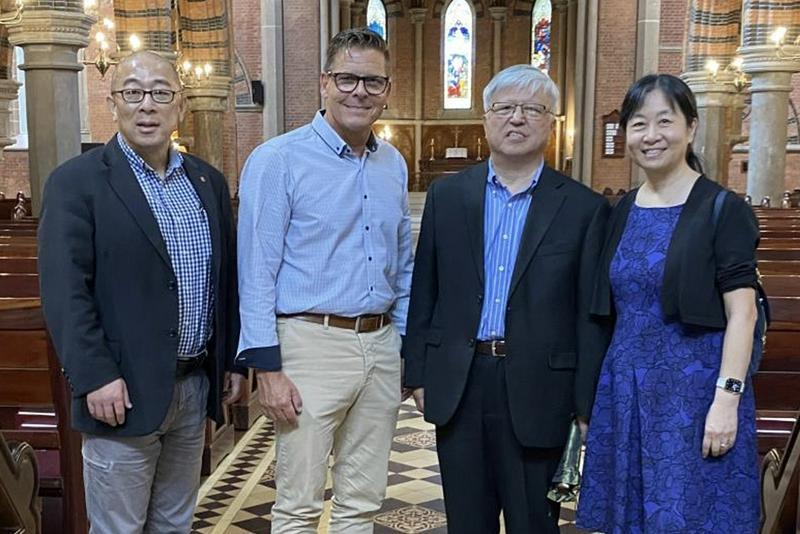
{"left": 403, "top": 163, "right": 610, "bottom": 447}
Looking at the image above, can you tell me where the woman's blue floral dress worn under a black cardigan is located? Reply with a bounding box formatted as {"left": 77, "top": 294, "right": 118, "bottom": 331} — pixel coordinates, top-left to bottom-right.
{"left": 577, "top": 204, "right": 760, "bottom": 534}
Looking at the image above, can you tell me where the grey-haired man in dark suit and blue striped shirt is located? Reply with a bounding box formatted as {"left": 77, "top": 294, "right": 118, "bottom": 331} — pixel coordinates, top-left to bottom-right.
{"left": 403, "top": 65, "right": 609, "bottom": 534}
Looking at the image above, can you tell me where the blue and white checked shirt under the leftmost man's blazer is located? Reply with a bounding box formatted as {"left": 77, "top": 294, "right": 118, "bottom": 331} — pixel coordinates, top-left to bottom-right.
{"left": 117, "top": 134, "right": 214, "bottom": 355}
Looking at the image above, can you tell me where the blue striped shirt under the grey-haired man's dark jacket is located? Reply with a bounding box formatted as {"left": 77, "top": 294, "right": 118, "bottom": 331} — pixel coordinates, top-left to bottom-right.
{"left": 477, "top": 159, "right": 544, "bottom": 340}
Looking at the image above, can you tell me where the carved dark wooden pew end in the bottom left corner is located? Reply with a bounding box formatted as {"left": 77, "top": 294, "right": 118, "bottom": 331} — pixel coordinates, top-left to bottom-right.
{"left": 0, "top": 434, "right": 41, "bottom": 534}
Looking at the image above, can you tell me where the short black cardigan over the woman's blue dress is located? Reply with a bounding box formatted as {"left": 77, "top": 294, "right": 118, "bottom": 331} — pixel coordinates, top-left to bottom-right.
{"left": 591, "top": 176, "right": 759, "bottom": 329}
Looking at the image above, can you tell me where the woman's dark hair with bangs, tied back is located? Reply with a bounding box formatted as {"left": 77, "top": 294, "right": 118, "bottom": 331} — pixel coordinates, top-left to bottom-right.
{"left": 619, "top": 74, "right": 703, "bottom": 174}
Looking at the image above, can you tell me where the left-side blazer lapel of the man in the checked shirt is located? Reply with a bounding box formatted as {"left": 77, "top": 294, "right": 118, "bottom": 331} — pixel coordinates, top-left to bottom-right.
{"left": 105, "top": 136, "right": 172, "bottom": 268}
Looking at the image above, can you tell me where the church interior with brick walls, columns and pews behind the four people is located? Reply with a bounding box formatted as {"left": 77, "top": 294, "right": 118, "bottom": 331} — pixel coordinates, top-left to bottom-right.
{"left": 0, "top": 0, "right": 800, "bottom": 534}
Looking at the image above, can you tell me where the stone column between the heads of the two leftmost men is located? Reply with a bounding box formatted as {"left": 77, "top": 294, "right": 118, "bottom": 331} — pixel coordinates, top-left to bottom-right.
{"left": 184, "top": 76, "right": 231, "bottom": 171}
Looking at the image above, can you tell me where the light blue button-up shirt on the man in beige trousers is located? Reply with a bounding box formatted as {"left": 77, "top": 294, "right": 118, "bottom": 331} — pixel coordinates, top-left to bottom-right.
{"left": 237, "top": 112, "right": 412, "bottom": 370}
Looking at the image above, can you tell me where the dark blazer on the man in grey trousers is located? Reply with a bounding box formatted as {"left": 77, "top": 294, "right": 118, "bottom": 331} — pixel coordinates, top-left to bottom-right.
{"left": 39, "top": 136, "right": 239, "bottom": 436}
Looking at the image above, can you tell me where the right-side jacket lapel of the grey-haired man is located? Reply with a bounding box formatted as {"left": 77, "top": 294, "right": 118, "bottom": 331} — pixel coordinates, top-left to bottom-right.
{"left": 508, "top": 166, "right": 564, "bottom": 297}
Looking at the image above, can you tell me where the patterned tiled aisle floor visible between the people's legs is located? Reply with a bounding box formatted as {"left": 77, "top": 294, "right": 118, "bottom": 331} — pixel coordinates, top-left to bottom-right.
{"left": 193, "top": 403, "right": 578, "bottom": 534}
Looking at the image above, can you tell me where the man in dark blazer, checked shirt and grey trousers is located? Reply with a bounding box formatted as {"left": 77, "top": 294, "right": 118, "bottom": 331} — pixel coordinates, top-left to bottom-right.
{"left": 39, "top": 52, "right": 242, "bottom": 534}
